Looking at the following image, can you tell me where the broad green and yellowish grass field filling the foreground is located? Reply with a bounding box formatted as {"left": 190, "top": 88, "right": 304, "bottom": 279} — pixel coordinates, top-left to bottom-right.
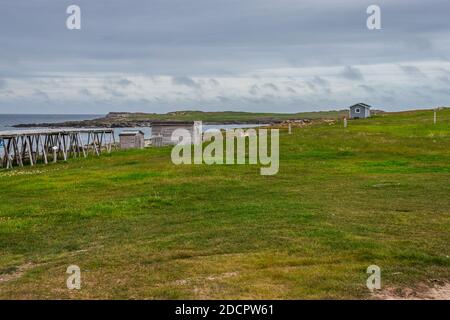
{"left": 0, "top": 109, "right": 450, "bottom": 299}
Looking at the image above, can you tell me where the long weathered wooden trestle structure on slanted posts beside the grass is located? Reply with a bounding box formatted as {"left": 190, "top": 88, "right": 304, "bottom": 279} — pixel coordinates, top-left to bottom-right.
{"left": 0, "top": 128, "right": 116, "bottom": 169}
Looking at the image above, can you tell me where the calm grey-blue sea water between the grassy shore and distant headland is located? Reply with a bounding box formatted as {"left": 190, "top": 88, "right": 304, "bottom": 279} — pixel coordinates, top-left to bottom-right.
{"left": 0, "top": 114, "right": 268, "bottom": 139}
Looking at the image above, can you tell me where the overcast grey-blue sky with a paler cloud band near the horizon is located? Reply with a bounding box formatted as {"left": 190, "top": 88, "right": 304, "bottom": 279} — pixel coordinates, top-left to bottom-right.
{"left": 0, "top": 0, "right": 450, "bottom": 113}
